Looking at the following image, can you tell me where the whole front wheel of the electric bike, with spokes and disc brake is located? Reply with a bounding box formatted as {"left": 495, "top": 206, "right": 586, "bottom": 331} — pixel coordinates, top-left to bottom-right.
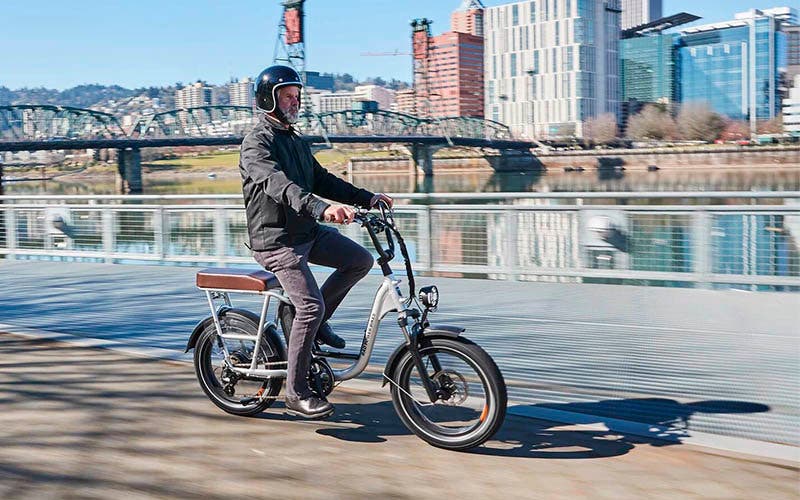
{"left": 391, "top": 337, "right": 508, "bottom": 450}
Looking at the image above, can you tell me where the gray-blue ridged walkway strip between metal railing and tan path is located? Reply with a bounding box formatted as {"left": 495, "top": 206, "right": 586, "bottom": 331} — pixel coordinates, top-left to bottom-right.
{"left": 0, "top": 261, "right": 800, "bottom": 450}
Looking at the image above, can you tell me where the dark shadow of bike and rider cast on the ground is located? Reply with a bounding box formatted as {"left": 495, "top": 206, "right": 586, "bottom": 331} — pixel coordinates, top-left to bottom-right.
{"left": 257, "top": 398, "right": 769, "bottom": 460}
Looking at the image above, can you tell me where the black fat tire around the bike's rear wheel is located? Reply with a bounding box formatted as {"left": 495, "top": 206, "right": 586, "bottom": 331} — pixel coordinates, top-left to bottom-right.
{"left": 194, "top": 310, "right": 285, "bottom": 416}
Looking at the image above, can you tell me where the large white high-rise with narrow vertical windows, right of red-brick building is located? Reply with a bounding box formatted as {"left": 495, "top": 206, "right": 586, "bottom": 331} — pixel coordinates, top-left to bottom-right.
{"left": 484, "top": 0, "right": 620, "bottom": 137}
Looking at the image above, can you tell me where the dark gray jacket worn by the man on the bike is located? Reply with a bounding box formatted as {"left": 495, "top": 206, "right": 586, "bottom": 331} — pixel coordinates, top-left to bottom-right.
{"left": 239, "top": 116, "right": 373, "bottom": 251}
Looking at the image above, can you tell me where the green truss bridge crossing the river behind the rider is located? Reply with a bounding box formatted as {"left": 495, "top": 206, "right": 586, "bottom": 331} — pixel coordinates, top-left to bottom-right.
{"left": 0, "top": 105, "right": 534, "bottom": 192}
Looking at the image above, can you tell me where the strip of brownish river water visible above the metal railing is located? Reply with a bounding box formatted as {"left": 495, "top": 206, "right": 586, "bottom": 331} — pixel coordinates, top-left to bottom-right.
{"left": 4, "top": 166, "right": 800, "bottom": 195}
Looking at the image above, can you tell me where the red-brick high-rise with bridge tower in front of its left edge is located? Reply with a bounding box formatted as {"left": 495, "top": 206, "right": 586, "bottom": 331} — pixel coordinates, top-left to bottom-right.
{"left": 411, "top": 10, "right": 484, "bottom": 117}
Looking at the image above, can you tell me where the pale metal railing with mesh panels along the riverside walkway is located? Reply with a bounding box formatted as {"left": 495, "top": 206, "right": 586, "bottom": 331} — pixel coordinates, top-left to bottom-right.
{"left": 0, "top": 192, "right": 800, "bottom": 289}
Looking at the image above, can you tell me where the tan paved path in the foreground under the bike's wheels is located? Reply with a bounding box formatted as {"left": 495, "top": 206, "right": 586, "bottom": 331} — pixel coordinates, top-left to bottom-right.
{"left": 0, "top": 334, "right": 800, "bottom": 500}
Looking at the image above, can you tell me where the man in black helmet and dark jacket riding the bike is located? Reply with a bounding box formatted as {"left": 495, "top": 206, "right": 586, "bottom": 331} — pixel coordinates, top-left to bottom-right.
{"left": 239, "top": 66, "right": 392, "bottom": 418}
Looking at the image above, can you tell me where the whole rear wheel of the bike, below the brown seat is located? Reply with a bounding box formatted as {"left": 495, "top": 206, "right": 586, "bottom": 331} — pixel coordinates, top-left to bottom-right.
{"left": 194, "top": 311, "right": 285, "bottom": 415}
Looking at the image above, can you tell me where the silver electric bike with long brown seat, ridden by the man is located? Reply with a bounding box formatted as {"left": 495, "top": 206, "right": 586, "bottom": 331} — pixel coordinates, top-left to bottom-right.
{"left": 186, "top": 203, "right": 507, "bottom": 450}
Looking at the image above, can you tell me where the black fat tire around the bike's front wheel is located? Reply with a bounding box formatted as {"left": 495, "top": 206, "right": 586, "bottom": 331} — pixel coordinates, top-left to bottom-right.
{"left": 391, "top": 337, "right": 508, "bottom": 451}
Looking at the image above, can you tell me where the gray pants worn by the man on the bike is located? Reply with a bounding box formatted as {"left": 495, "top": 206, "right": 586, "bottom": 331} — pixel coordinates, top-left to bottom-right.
{"left": 254, "top": 226, "right": 374, "bottom": 399}
